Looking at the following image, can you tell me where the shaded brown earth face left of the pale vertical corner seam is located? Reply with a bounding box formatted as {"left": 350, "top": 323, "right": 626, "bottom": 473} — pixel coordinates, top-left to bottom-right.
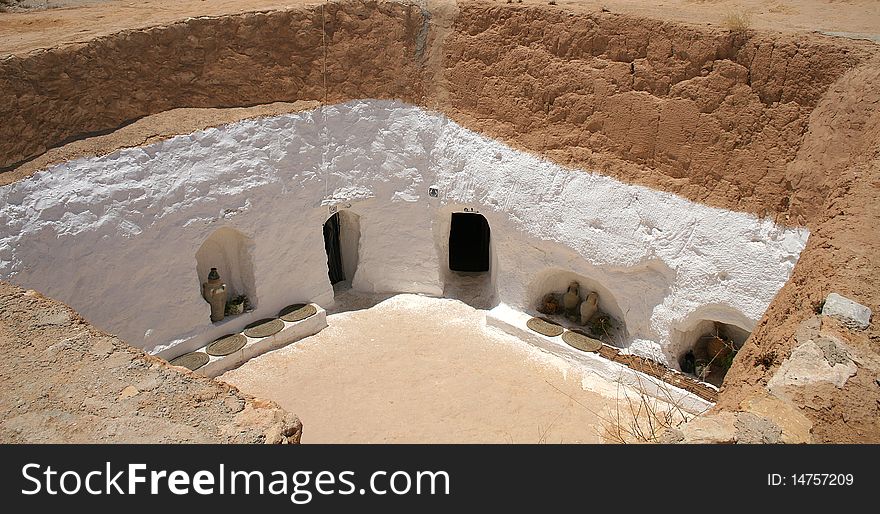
{"left": 0, "top": 2, "right": 424, "bottom": 171}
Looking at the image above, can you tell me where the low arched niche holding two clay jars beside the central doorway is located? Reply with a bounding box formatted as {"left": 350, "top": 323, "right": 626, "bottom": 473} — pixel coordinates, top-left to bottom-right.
{"left": 527, "top": 268, "right": 629, "bottom": 347}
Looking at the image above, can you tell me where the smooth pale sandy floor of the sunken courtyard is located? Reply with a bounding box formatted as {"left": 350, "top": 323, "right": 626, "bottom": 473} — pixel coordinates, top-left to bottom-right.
{"left": 219, "top": 295, "right": 648, "bottom": 443}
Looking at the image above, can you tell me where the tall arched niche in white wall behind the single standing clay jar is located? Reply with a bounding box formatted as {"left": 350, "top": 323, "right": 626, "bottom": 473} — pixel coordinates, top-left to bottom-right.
{"left": 196, "top": 227, "right": 257, "bottom": 306}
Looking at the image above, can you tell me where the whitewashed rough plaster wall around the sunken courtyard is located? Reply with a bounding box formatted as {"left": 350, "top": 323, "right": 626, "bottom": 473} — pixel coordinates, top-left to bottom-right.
{"left": 0, "top": 100, "right": 808, "bottom": 363}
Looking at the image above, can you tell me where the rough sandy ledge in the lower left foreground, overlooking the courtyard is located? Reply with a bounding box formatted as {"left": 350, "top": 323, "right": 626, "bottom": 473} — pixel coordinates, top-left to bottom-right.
{"left": 0, "top": 282, "right": 302, "bottom": 444}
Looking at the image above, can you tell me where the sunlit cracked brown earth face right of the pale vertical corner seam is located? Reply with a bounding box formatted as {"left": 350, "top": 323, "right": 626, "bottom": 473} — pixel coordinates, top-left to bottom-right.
{"left": 444, "top": 6, "right": 865, "bottom": 222}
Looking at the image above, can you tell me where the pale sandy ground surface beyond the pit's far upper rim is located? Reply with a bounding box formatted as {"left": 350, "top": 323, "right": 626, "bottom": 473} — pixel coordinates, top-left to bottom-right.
{"left": 0, "top": 0, "right": 880, "bottom": 54}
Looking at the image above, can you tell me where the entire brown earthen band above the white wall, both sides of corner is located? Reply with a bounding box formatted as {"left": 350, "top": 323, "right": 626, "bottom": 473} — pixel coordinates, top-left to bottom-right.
{"left": 0, "top": 2, "right": 869, "bottom": 218}
